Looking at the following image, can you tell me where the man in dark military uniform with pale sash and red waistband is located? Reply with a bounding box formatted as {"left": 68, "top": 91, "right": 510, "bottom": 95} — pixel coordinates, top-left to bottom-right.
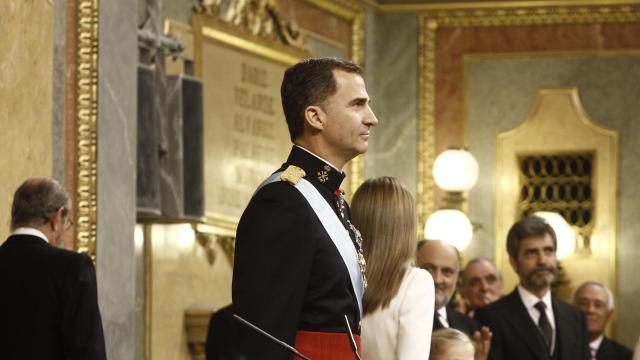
{"left": 233, "top": 58, "right": 378, "bottom": 360}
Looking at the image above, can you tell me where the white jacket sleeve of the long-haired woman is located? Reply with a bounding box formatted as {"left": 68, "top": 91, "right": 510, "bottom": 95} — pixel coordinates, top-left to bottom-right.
{"left": 396, "top": 269, "right": 435, "bottom": 360}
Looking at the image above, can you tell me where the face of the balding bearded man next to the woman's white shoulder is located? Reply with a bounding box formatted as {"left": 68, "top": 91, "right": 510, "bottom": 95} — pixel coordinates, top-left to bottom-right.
{"left": 416, "top": 240, "right": 460, "bottom": 310}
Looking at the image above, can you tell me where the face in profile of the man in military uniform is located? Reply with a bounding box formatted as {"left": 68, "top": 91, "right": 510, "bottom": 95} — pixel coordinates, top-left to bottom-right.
{"left": 320, "top": 70, "right": 378, "bottom": 162}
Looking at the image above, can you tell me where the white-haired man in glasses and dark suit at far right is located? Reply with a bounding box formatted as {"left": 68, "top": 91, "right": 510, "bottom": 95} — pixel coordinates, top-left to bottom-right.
{"left": 573, "top": 281, "right": 633, "bottom": 360}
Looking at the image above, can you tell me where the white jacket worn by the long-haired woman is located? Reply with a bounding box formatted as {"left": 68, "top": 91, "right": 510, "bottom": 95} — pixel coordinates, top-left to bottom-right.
{"left": 361, "top": 267, "right": 435, "bottom": 360}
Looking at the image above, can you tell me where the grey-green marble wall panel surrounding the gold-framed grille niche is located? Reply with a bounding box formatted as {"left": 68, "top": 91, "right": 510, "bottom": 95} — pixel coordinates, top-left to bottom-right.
{"left": 466, "top": 52, "right": 640, "bottom": 346}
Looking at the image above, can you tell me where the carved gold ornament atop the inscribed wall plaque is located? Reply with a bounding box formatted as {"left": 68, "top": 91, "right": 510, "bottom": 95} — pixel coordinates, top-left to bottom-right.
{"left": 193, "top": 0, "right": 307, "bottom": 51}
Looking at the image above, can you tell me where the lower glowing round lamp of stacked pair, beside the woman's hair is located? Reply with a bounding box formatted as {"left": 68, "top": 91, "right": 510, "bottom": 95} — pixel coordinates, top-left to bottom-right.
{"left": 424, "top": 209, "right": 473, "bottom": 251}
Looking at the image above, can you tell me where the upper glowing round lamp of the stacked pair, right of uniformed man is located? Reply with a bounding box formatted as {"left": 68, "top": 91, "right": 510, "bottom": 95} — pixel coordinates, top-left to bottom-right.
{"left": 433, "top": 149, "right": 478, "bottom": 192}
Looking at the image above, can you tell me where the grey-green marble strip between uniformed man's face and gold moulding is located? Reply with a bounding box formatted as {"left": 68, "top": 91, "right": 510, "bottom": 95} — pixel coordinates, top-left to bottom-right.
{"left": 365, "top": 13, "right": 418, "bottom": 196}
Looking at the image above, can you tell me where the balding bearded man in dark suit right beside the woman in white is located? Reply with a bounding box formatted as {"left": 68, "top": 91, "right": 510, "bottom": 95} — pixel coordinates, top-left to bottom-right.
{"left": 416, "top": 240, "right": 479, "bottom": 337}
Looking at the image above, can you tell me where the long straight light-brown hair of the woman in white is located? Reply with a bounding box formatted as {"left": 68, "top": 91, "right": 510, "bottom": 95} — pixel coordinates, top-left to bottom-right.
{"left": 351, "top": 177, "right": 418, "bottom": 315}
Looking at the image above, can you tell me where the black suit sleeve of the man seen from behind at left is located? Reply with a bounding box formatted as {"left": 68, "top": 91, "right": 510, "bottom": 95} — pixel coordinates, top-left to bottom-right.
{"left": 61, "top": 255, "right": 106, "bottom": 360}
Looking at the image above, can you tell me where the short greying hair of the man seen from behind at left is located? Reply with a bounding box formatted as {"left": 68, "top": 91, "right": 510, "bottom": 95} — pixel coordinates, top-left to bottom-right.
{"left": 11, "top": 177, "right": 69, "bottom": 230}
